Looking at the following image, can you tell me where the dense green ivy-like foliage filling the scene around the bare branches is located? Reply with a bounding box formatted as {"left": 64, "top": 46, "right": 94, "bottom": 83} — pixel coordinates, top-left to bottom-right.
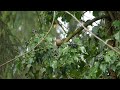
{"left": 0, "top": 11, "right": 120, "bottom": 79}
